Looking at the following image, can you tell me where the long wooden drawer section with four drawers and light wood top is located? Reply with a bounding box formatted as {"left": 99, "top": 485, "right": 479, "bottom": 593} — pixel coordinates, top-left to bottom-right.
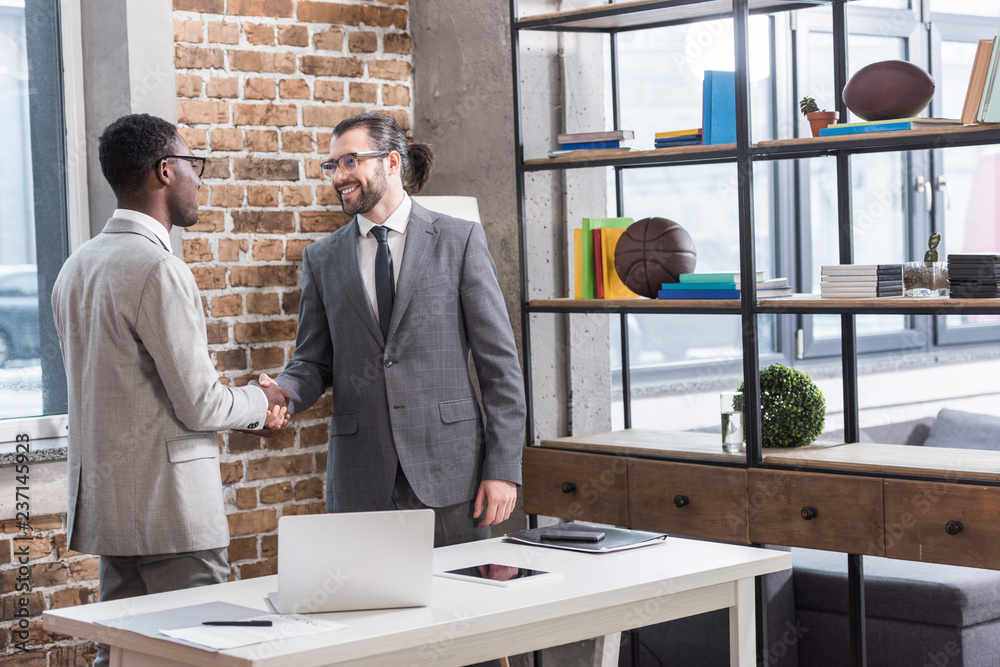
{"left": 523, "top": 429, "right": 1000, "bottom": 569}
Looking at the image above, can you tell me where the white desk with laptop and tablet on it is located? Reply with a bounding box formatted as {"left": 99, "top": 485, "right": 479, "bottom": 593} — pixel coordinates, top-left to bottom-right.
{"left": 44, "top": 537, "right": 792, "bottom": 667}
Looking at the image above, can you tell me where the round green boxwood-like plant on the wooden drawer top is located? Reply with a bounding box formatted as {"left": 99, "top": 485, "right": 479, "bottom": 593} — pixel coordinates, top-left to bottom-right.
{"left": 740, "top": 364, "right": 826, "bottom": 447}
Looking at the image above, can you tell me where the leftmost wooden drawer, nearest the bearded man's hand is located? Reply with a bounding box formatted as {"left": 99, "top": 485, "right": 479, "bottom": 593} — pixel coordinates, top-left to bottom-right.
{"left": 521, "top": 447, "right": 629, "bottom": 526}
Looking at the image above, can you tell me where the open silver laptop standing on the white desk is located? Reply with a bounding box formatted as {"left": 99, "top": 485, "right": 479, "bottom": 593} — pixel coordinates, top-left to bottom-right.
{"left": 267, "top": 509, "right": 434, "bottom": 614}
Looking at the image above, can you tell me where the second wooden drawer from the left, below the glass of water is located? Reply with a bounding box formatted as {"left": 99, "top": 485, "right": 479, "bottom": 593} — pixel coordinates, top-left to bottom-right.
{"left": 628, "top": 459, "right": 749, "bottom": 544}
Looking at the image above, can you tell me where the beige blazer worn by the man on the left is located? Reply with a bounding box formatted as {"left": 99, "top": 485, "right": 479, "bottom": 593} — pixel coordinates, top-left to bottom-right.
{"left": 52, "top": 218, "right": 267, "bottom": 556}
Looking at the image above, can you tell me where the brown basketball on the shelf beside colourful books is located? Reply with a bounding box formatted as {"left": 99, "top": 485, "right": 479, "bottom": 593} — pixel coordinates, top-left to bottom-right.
{"left": 615, "top": 218, "right": 697, "bottom": 299}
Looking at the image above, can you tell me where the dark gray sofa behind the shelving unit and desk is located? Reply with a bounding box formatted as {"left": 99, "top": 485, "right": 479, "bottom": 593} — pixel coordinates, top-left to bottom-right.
{"left": 619, "top": 409, "right": 1000, "bottom": 667}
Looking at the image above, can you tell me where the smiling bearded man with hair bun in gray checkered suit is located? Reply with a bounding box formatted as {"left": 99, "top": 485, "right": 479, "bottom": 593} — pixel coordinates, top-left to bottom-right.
{"left": 270, "top": 114, "right": 525, "bottom": 546}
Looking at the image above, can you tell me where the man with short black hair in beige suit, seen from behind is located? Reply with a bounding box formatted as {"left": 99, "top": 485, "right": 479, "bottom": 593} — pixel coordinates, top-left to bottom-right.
{"left": 52, "top": 114, "right": 288, "bottom": 665}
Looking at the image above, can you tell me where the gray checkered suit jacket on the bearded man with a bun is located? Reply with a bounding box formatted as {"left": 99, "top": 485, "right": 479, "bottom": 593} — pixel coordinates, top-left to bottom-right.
{"left": 277, "top": 202, "right": 525, "bottom": 512}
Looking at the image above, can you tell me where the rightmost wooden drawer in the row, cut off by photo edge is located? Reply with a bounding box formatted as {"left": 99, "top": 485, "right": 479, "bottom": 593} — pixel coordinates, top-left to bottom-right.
{"left": 885, "top": 479, "right": 1000, "bottom": 569}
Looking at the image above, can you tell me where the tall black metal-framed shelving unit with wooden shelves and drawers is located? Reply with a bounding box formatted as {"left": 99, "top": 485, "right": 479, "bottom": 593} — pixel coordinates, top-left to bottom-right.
{"left": 511, "top": 0, "right": 1000, "bottom": 667}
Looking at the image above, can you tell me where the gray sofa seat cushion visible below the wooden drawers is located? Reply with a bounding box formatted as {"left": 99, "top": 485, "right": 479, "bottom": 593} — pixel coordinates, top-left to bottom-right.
{"left": 792, "top": 549, "right": 1000, "bottom": 627}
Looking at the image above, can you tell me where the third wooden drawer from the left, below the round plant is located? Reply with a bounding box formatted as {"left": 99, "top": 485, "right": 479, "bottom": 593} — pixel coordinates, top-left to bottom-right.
{"left": 747, "top": 469, "right": 885, "bottom": 556}
